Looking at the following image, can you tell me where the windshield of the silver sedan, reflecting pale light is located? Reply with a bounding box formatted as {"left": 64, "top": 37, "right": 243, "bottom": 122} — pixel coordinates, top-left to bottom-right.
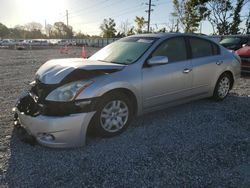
{"left": 89, "top": 37, "right": 157, "bottom": 64}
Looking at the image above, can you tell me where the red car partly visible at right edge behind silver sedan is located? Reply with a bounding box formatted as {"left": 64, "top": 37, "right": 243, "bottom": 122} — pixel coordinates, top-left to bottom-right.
{"left": 235, "top": 42, "right": 250, "bottom": 73}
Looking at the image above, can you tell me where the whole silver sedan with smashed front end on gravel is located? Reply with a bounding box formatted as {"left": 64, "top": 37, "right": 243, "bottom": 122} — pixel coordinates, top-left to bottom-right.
{"left": 15, "top": 33, "right": 240, "bottom": 148}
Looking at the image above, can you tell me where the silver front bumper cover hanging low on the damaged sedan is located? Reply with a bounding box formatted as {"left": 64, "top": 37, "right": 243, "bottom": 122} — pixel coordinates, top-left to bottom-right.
{"left": 17, "top": 110, "right": 95, "bottom": 148}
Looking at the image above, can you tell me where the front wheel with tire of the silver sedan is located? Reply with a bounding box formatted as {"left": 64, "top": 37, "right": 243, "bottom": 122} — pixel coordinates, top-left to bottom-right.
{"left": 93, "top": 93, "right": 133, "bottom": 137}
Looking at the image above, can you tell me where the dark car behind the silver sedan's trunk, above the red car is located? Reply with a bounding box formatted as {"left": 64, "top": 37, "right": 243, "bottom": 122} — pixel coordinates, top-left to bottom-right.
{"left": 220, "top": 36, "right": 250, "bottom": 51}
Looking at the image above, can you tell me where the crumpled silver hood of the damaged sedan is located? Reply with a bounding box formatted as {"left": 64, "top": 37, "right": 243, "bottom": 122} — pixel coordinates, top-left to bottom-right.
{"left": 36, "top": 58, "right": 126, "bottom": 84}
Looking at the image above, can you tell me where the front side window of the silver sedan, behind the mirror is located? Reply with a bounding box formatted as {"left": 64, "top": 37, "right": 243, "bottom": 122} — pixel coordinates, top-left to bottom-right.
{"left": 152, "top": 37, "right": 187, "bottom": 63}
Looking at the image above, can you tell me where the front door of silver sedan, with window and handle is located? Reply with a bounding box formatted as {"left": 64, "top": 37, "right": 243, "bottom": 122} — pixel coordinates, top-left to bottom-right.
{"left": 142, "top": 37, "right": 192, "bottom": 108}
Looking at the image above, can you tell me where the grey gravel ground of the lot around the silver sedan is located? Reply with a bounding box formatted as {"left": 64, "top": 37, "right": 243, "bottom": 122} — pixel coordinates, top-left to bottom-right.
{"left": 0, "top": 48, "right": 250, "bottom": 187}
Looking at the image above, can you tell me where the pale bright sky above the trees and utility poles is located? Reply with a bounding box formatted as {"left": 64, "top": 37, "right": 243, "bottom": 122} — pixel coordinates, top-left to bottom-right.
{"left": 0, "top": 0, "right": 249, "bottom": 35}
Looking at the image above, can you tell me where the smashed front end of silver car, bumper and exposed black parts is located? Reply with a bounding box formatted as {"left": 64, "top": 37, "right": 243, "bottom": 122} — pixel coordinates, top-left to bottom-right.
{"left": 14, "top": 81, "right": 98, "bottom": 147}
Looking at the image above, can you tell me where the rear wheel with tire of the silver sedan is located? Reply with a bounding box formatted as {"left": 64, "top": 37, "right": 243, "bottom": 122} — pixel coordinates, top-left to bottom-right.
{"left": 213, "top": 73, "right": 232, "bottom": 101}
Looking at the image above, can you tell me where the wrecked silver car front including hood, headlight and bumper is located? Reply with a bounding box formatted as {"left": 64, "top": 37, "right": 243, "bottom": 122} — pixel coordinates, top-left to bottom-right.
{"left": 14, "top": 59, "right": 123, "bottom": 148}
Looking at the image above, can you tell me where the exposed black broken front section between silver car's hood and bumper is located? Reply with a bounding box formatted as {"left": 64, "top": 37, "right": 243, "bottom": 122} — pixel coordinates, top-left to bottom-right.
{"left": 16, "top": 81, "right": 98, "bottom": 117}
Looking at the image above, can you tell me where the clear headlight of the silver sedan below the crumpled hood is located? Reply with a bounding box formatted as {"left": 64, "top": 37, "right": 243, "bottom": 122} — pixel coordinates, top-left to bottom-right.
{"left": 46, "top": 80, "right": 93, "bottom": 102}
